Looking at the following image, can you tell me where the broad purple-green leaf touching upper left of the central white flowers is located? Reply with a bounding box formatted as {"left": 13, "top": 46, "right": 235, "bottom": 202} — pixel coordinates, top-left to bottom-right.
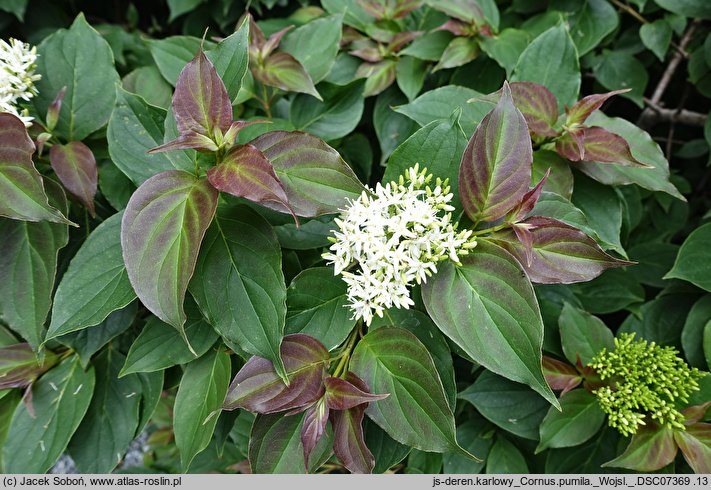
{"left": 250, "top": 131, "right": 365, "bottom": 217}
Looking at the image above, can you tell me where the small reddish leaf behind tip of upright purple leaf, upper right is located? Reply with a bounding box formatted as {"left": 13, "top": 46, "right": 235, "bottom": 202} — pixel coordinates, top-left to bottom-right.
{"left": 511, "top": 82, "right": 558, "bottom": 137}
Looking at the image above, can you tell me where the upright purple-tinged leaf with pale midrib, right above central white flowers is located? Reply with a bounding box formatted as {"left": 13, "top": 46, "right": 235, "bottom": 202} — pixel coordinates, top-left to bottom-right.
{"left": 459, "top": 82, "right": 533, "bottom": 223}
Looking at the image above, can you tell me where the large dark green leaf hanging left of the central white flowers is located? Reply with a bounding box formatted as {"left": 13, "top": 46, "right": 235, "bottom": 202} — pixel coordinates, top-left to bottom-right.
{"left": 190, "top": 206, "right": 286, "bottom": 378}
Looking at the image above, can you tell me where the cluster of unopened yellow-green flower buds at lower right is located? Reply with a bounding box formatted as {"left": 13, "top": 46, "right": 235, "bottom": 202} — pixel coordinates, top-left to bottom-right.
{"left": 589, "top": 333, "right": 704, "bottom": 436}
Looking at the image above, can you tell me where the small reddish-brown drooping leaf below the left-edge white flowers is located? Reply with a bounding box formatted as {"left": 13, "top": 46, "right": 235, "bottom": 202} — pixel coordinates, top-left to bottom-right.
{"left": 49, "top": 141, "right": 99, "bottom": 216}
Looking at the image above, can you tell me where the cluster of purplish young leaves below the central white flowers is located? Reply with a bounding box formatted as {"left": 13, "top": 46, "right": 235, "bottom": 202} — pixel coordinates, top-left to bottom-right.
{"left": 223, "top": 334, "right": 387, "bottom": 473}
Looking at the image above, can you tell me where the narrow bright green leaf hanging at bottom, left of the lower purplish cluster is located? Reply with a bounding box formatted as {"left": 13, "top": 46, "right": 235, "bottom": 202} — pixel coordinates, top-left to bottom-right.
{"left": 173, "top": 350, "right": 230, "bottom": 471}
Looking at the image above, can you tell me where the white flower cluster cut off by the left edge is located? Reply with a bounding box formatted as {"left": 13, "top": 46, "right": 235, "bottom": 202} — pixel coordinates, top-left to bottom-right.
{"left": 0, "top": 39, "right": 40, "bottom": 126}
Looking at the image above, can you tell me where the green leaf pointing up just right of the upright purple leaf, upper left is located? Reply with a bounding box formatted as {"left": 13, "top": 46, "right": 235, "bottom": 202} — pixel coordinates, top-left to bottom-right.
{"left": 206, "top": 19, "right": 249, "bottom": 103}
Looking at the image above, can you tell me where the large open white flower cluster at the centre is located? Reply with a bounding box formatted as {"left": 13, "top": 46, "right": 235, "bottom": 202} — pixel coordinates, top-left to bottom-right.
{"left": 323, "top": 164, "right": 476, "bottom": 324}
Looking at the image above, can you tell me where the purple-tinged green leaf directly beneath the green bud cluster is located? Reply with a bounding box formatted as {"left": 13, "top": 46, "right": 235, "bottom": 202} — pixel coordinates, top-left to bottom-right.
{"left": 602, "top": 423, "right": 677, "bottom": 473}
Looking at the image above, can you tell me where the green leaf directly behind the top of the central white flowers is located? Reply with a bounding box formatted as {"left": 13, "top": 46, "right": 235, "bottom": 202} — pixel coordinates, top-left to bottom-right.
{"left": 382, "top": 115, "right": 467, "bottom": 210}
